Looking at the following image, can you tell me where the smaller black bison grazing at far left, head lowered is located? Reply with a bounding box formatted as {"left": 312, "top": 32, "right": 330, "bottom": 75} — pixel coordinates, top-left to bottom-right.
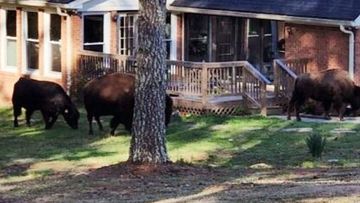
{"left": 12, "top": 77, "right": 79, "bottom": 129}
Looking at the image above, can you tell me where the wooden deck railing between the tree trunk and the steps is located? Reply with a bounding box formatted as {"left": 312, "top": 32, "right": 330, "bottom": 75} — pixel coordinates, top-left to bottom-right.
{"left": 167, "top": 61, "right": 270, "bottom": 115}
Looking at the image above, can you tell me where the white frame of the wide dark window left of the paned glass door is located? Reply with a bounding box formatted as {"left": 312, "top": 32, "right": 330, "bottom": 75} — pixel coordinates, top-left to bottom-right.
{"left": 81, "top": 12, "right": 111, "bottom": 54}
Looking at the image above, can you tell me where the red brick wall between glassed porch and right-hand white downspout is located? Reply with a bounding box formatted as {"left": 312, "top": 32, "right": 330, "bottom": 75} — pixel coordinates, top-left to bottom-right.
{"left": 285, "top": 24, "right": 349, "bottom": 71}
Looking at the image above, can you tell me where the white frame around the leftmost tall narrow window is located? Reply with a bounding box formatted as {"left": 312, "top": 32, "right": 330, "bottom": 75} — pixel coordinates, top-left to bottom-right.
{"left": 0, "top": 7, "right": 19, "bottom": 72}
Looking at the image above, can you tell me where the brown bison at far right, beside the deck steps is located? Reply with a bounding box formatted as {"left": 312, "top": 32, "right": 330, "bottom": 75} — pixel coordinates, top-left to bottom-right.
{"left": 288, "top": 69, "right": 360, "bottom": 121}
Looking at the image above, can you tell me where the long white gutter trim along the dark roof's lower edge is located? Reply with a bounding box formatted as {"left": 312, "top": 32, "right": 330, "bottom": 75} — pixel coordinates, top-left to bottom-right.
{"left": 168, "top": 6, "right": 354, "bottom": 26}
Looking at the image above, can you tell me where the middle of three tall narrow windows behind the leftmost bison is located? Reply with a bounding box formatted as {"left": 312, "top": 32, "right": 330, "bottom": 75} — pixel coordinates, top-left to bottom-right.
{"left": 26, "top": 12, "right": 39, "bottom": 69}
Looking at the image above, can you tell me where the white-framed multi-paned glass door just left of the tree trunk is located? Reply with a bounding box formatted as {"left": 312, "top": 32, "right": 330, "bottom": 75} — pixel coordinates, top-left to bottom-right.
{"left": 116, "top": 12, "right": 139, "bottom": 56}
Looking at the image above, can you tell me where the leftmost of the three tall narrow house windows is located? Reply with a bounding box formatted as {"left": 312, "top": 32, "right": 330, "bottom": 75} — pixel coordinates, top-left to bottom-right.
{"left": 6, "top": 10, "right": 17, "bottom": 67}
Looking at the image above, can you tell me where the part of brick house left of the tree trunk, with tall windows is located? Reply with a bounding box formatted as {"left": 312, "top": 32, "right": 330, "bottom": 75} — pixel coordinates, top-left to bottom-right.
{"left": 0, "top": 0, "right": 143, "bottom": 101}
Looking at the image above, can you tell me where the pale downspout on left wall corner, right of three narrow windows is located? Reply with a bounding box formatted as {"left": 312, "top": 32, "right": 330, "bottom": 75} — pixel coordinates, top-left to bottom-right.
{"left": 56, "top": 7, "right": 73, "bottom": 95}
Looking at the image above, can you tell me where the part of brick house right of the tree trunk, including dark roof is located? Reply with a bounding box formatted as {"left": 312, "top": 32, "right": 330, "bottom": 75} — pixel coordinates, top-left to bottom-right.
{"left": 169, "top": 0, "right": 360, "bottom": 83}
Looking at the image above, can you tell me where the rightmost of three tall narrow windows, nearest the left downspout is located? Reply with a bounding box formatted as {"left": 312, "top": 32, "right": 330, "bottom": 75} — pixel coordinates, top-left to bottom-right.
{"left": 49, "top": 14, "right": 61, "bottom": 72}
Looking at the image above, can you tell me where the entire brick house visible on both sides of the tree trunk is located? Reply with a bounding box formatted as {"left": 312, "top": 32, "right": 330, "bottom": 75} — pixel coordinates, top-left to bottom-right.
{"left": 0, "top": 0, "right": 360, "bottom": 114}
